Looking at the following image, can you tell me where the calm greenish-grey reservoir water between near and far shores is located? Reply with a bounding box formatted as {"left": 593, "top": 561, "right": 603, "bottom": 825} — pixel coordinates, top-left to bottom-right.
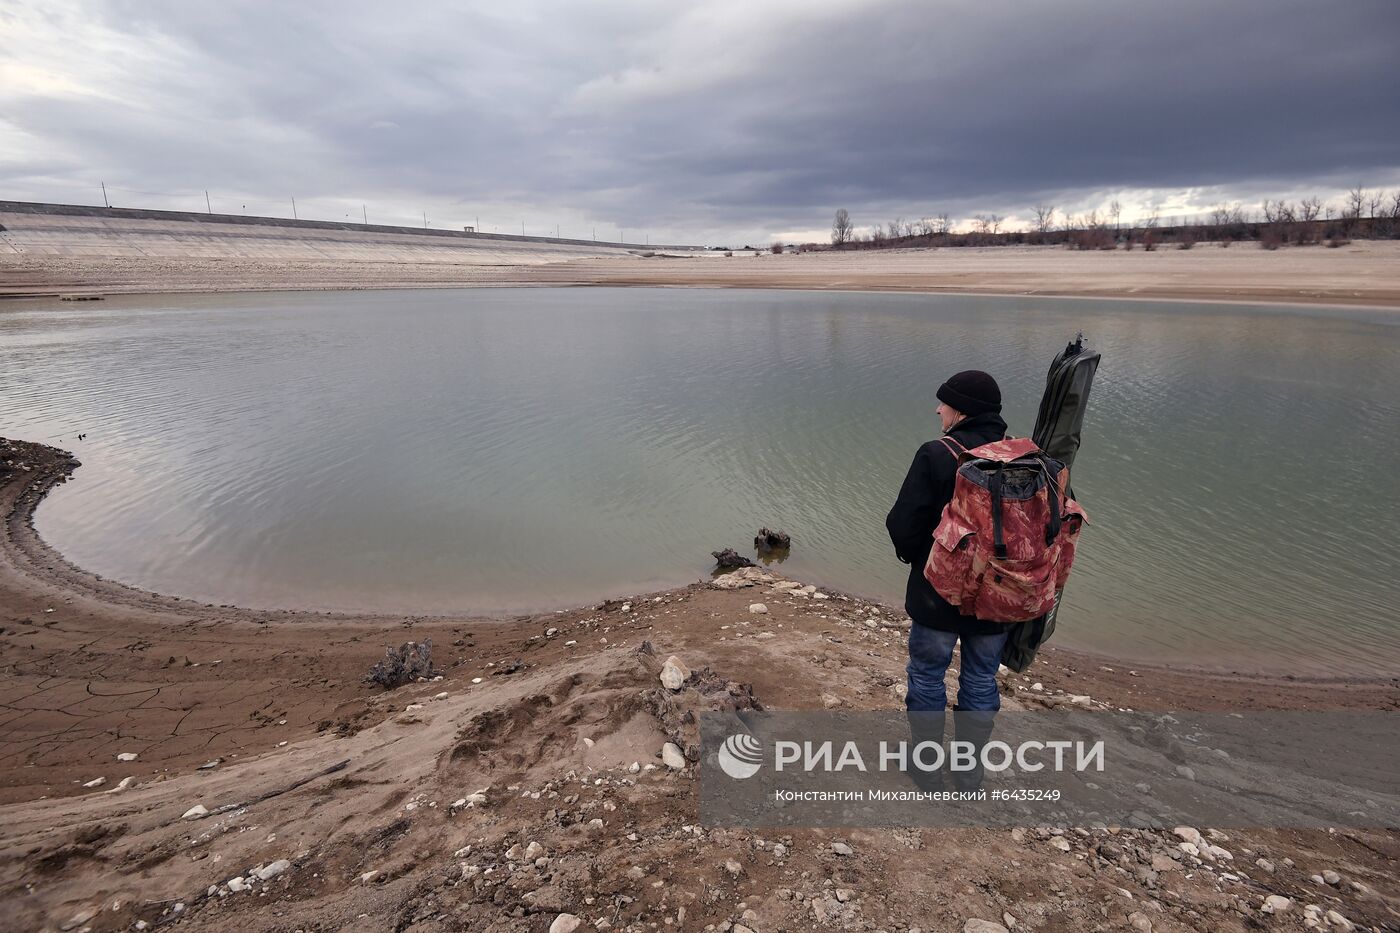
{"left": 0, "top": 282, "right": 1400, "bottom": 672}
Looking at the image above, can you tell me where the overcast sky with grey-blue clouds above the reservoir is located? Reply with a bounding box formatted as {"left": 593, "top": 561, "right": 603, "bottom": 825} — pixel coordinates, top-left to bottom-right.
{"left": 0, "top": 0, "right": 1400, "bottom": 244}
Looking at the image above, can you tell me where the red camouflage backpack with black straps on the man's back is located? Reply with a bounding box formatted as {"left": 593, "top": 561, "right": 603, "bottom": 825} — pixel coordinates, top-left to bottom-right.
{"left": 924, "top": 437, "right": 1086, "bottom": 622}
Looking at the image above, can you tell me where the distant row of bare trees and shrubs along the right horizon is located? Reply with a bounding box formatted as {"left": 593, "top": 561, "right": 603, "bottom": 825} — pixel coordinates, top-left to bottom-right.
{"left": 771, "top": 186, "right": 1400, "bottom": 252}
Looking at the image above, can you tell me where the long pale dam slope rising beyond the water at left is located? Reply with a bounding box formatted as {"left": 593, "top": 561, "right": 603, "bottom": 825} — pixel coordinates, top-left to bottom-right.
{"left": 0, "top": 200, "right": 706, "bottom": 297}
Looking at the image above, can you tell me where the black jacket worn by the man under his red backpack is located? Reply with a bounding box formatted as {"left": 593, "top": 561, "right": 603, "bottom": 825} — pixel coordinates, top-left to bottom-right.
{"left": 885, "top": 415, "right": 1007, "bottom": 635}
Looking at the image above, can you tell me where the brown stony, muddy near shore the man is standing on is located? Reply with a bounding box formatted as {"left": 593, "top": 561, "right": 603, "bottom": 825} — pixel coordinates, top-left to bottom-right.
{"left": 0, "top": 441, "right": 1400, "bottom": 933}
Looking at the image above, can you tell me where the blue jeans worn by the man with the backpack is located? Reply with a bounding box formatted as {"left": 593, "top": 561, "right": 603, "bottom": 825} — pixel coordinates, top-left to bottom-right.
{"left": 904, "top": 622, "right": 1011, "bottom": 713}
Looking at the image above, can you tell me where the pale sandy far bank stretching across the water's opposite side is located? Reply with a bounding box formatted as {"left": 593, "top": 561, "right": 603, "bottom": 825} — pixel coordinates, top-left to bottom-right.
{"left": 8, "top": 241, "right": 1400, "bottom": 308}
